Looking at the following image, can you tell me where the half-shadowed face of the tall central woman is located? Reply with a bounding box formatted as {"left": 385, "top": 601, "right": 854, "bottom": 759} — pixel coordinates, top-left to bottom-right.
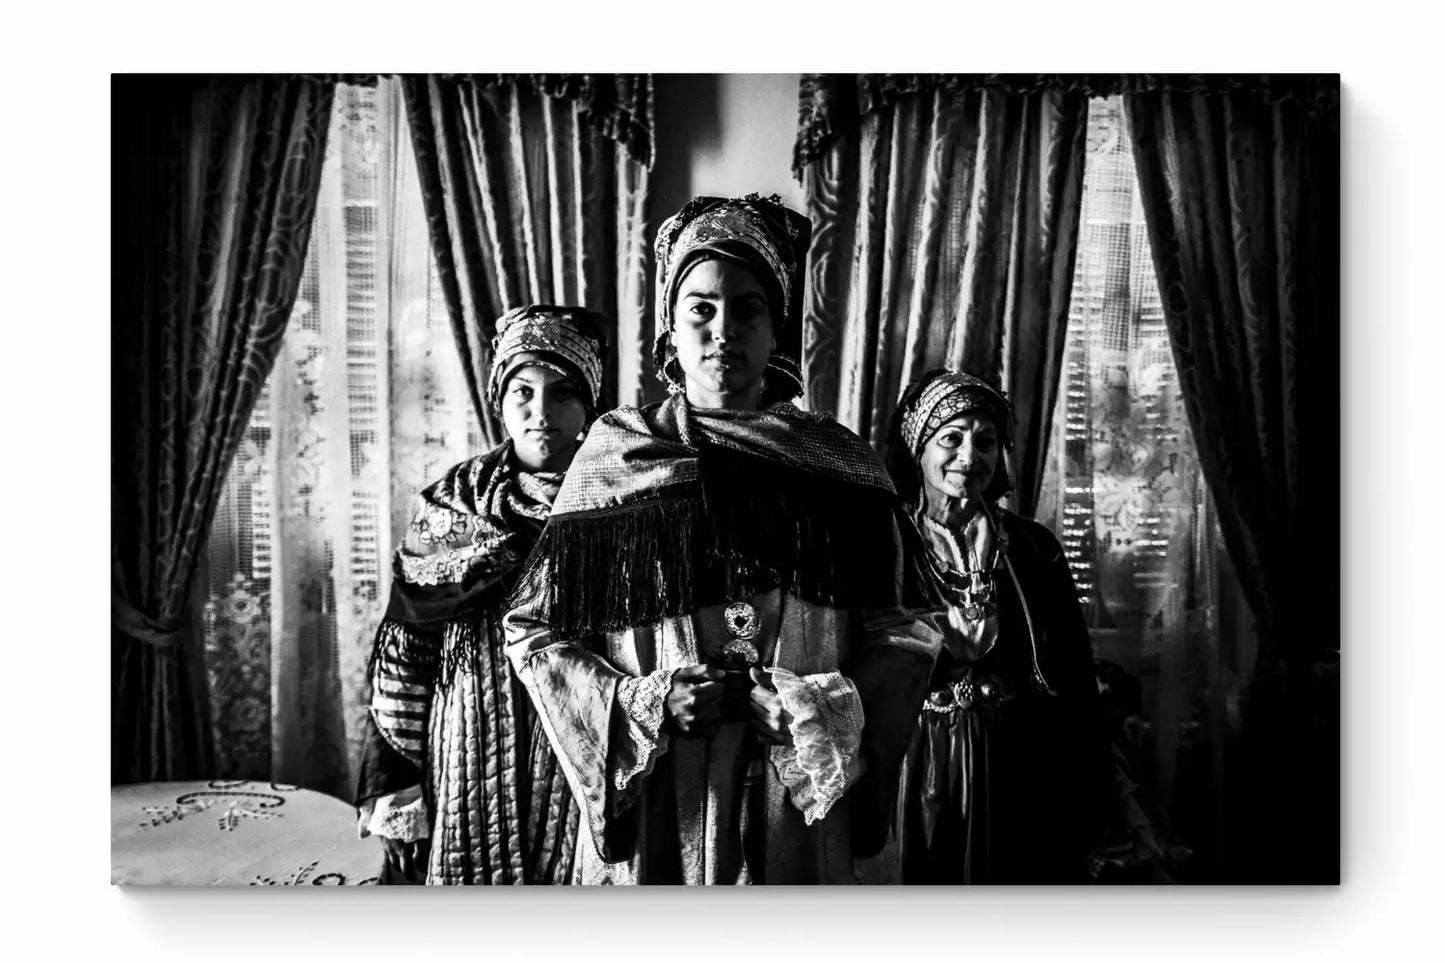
{"left": 672, "top": 259, "right": 773, "bottom": 408}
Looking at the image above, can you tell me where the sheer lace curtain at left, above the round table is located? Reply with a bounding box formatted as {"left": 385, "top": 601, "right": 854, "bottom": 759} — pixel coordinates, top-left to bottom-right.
{"left": 205, "top": 78, "right": 481, "bottom": 798}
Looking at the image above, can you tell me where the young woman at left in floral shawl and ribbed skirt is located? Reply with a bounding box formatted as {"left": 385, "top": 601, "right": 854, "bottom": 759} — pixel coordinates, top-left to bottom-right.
{"left": 357, "top": 305, "right": 604, "bottom": 885}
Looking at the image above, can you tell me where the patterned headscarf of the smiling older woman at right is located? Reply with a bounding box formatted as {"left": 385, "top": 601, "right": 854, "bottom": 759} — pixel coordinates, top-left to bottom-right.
{"left": 886, "top": 369, "right": 1013, "bottom": 506}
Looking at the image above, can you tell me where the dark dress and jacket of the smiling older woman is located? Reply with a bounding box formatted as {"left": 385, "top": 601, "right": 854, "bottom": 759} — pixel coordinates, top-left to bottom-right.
{"left": 897, "top": 509, "right": 1111, "bottom": 883}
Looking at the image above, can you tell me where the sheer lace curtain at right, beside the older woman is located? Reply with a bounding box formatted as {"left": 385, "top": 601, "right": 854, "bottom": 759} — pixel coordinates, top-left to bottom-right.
{"left": 1038, "top": 97, "right": 1250, "bottom": 879}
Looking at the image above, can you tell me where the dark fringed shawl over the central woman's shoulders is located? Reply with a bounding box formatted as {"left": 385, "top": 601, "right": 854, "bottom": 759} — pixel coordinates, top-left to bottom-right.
{"left": 519, "top": 396, "right": 938, "bottom": 639}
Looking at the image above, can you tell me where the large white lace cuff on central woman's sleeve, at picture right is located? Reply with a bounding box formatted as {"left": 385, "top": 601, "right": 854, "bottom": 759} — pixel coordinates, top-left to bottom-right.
{"left": 770, "top": 668, "right": 863, "bottom": 826}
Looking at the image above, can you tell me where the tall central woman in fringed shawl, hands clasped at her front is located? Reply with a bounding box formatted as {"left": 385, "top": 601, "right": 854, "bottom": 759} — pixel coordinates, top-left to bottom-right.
{"left": 506, "top": 195, "right": 939, "bottom": 883}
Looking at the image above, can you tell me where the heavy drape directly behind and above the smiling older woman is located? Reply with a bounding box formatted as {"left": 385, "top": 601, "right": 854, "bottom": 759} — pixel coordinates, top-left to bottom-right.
{"left": 795, "top": 75, "right": 1088, "bottom": 515}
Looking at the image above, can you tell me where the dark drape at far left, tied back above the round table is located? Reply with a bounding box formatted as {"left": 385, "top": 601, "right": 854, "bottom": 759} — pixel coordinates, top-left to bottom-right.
{"left": 111, "top": 77, "right": 334, "bottom": 782}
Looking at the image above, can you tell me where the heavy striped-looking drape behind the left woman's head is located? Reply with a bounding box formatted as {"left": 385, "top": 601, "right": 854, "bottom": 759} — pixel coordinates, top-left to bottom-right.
{"left": 402, "top": 74, "right": 652, "bottom": 444}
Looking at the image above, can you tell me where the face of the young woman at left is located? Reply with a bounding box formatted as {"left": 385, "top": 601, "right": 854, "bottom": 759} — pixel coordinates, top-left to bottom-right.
{"left": 501, "top": 364, "right": 587, "bottom": 471}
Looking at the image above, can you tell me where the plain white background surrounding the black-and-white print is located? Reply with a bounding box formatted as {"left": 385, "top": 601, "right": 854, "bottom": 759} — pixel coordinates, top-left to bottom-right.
{"left": 0, "top": 0, "right": 1445, "bottom": 963}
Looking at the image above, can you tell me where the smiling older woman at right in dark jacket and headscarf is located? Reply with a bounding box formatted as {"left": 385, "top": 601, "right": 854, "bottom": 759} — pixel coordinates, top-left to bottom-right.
{"left": 887, "top": 370, "right": 1113, "bottom": 883}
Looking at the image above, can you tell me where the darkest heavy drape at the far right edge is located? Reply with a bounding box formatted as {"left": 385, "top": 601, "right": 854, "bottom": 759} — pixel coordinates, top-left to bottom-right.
{"left": 1124, "top": 77, "right": 1340, "bottom": 882}
